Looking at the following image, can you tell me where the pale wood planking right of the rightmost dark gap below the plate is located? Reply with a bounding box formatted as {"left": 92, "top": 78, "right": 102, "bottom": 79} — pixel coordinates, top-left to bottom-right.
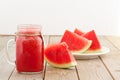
{"left": 101, "top": 36, "right": 120, "bottom": 80}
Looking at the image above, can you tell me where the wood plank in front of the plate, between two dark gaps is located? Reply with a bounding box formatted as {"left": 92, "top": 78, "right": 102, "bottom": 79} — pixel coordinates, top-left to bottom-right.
{"left": 77, "top": 36, "right": 113, "bottom": 80}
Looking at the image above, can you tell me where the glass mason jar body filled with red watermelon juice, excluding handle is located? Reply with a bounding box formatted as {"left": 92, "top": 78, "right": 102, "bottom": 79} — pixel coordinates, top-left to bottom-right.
{"left": 16, "top": 25, "right": 44, "bottom": 72}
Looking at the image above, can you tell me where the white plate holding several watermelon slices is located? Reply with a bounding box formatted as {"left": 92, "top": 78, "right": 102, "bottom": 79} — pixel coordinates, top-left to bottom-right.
{"left": 73, "top": 46, "right": 110, "bottom": 59}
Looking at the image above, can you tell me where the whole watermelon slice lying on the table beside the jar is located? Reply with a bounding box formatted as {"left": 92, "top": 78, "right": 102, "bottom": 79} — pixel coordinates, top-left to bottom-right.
{"left": 44, "top": 42, "right": 77, "bottom": 68}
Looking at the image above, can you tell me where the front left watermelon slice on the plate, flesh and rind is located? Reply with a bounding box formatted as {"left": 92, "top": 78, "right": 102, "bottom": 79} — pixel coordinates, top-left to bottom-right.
{"left": 61, "top": 30, "right": 92, "bottom": 53}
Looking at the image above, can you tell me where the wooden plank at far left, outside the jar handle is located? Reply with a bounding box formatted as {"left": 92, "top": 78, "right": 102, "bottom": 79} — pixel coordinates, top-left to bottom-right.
{"left": 0, "top": 35, "right": 14, "bottom": 80}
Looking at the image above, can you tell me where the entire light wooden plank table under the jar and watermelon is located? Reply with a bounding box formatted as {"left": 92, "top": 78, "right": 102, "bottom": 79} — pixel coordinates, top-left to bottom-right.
{"left": 0, "top": 35, "right": 120, "bottom": 80}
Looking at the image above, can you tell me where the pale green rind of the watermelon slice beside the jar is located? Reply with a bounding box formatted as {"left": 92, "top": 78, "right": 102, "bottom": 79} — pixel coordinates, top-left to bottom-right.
{"left": 44, "top": 56, "right": 77, "bottom": 68}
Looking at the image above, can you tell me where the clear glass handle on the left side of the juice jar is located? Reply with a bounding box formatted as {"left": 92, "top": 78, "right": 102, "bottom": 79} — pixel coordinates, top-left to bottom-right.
{"left": 6, "top": 39, "right": 16, "bottom": 65}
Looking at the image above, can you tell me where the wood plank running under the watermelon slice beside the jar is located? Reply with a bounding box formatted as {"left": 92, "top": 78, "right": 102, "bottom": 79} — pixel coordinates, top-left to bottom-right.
{"left": 45, "top": 36, "right": 79, "bottom": 80}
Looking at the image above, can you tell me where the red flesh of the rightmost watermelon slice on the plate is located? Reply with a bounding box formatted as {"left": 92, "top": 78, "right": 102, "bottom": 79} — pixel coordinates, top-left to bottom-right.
{"left": 82, "top": 30, "right": 101, "bottom": 52}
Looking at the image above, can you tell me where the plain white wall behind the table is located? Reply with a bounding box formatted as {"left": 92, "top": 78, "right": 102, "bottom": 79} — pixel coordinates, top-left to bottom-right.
{"left": 0, "top": 0, "right": 120, "bottom": 35}
